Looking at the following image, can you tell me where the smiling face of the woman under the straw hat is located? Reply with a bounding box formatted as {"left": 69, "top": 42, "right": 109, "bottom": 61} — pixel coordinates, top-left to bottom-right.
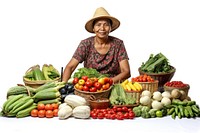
{"left": 93, "top": 19, "right": 111, "bottom": 38}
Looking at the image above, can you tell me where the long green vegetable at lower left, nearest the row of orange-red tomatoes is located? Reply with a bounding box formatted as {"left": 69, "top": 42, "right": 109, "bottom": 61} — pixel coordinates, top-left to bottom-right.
{"left": 16, "top": 103, "right": 37, "bottom": 118}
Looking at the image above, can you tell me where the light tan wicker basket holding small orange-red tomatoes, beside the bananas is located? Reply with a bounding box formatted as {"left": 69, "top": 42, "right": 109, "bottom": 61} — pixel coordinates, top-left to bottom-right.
{"left": 138, "top": 80, "right": 159, "bottom": 94}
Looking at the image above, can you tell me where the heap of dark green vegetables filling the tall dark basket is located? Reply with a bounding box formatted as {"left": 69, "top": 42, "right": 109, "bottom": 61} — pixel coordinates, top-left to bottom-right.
{"left": 140, "top": 53, "right": 174, "bottom": 73}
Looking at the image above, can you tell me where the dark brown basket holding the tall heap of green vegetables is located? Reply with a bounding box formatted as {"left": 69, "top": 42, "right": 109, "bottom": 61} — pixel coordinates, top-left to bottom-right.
{"left": 138, "top": 66, "right": 176, "bottom": 92}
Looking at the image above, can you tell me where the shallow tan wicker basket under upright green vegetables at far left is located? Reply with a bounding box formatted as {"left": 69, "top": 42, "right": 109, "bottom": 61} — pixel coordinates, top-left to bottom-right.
{"left": 23, "top": 77, "right": 61, "bottom": 89}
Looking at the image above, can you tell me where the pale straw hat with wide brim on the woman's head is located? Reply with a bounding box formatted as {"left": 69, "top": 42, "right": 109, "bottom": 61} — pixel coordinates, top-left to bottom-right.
{"left": 85, "top": 7, "right": 120, "bottom": 33}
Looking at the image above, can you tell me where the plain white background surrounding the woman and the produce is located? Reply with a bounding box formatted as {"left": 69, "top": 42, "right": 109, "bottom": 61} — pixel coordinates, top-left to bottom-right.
{"left": 0, "top": 0, "right": 200, "bottom": 132}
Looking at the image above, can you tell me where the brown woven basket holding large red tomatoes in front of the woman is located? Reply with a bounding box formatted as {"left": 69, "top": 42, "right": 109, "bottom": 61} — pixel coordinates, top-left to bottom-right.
{"left": 74, "top": 87, "right": 112, "bottom": 104}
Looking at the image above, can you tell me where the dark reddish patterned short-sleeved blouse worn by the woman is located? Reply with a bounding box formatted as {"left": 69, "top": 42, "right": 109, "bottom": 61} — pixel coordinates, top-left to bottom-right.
{"left": 73, "top": 36, "right": 129, "bottom": 77}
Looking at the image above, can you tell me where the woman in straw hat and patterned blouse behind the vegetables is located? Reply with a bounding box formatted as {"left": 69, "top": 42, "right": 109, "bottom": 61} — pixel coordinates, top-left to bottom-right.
{"left": 62, "top": 7, "right": 131, "bottom": 83}
